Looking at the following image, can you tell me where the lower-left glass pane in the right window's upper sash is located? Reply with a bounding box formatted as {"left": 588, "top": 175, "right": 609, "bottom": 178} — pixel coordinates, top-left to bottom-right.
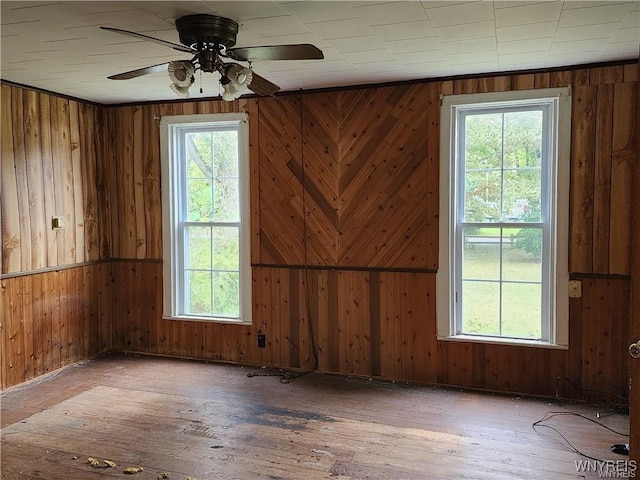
{"left": 464, "top": 170, "right": 502, "bottom": 222}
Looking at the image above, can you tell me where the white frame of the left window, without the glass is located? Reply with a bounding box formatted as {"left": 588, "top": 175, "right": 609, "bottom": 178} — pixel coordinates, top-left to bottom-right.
{"left": 160, "top": 113, "right": 252, "bottom": 325}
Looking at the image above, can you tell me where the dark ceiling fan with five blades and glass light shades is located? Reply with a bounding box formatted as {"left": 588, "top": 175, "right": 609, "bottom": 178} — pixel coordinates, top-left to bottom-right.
{"left": 100, "top": 14, "right": 324, "bottom": 101}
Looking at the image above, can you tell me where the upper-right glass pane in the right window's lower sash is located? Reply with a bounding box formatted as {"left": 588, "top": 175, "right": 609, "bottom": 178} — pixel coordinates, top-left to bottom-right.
{"left": 502, "top": 228, "right": 542, "bottom": 282}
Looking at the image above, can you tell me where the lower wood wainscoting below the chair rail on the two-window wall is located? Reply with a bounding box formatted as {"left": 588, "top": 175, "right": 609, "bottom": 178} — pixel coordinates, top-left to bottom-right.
{"left": 107, "top": 261, "right": 629, "bottom": 401}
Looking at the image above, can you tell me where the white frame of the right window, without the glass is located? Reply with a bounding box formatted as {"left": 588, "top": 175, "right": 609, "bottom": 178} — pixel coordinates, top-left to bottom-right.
{"left": 436, "top": 87, "right": 571, "bottom": 349}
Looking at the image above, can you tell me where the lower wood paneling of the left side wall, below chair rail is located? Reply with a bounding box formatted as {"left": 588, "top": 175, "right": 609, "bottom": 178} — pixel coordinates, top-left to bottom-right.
{"left": 0, "top": 263, "right": 112, "bottom": 389}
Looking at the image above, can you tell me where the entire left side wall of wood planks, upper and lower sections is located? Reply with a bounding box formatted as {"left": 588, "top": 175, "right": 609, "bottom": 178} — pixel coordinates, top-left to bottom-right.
{"left": 0, "top": 84, "right": 112, "bottom": 388}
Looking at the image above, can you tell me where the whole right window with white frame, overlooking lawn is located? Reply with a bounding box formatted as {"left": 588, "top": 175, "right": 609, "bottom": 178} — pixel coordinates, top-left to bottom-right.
{"left": 438, "top": 89, "right": 571, "bottom": 347}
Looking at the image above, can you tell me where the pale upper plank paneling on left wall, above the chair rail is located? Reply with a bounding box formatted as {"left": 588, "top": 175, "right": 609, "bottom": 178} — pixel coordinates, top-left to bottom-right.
{"left": 0, "top": 85, "right": 109, "bottom": 274}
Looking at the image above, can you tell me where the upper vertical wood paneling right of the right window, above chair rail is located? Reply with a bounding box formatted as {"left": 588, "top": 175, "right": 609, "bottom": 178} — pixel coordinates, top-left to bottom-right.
{"left": 570, "top": 69, "right": 638, "bottom": 275}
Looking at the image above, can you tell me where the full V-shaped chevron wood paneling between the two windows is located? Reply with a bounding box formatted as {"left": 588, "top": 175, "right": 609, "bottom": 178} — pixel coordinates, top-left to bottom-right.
{"left": 259, "top": 85, "right": 438, "bottom": 269}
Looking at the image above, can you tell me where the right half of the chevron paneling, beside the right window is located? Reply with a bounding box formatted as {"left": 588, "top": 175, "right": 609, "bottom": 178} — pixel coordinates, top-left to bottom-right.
{"left": 339, "top": 85, "right": 438, "bottom": 269}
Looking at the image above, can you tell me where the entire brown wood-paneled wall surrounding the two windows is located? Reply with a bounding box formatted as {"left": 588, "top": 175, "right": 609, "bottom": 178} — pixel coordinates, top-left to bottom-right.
{"left": 3, "top": 64, "right": 638, "bottom": 396}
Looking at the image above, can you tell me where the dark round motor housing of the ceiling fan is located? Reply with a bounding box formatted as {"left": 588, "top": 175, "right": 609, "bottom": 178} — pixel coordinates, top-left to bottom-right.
{"left": 176, "top": 14, "right": 238, "bottom": 50}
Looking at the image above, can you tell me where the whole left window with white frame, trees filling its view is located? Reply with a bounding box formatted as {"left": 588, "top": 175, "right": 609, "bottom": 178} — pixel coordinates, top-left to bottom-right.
{"left": 160, "top": 114, "right": 251, "bottom": 323}
